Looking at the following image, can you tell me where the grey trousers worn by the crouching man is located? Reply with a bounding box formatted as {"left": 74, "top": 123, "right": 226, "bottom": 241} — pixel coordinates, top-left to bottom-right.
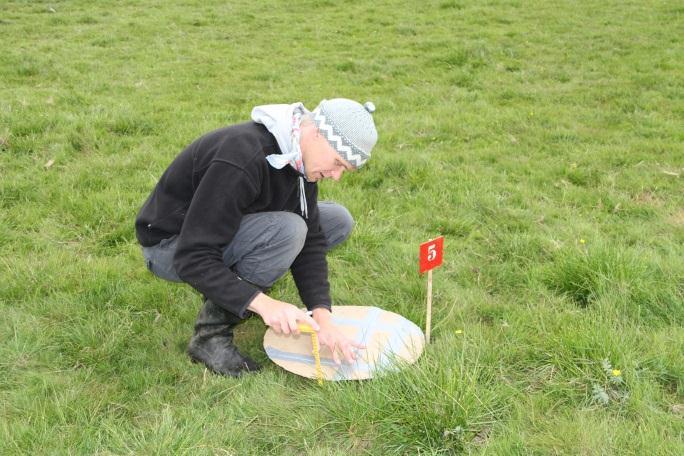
{"left": 142, "top": 201, "right": 354, "bottom": 288}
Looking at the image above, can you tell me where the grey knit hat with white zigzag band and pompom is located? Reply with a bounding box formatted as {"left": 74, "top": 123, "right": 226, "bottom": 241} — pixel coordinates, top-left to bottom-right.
{"left": 312, "top": 98, "right": 378, "bottom": 168}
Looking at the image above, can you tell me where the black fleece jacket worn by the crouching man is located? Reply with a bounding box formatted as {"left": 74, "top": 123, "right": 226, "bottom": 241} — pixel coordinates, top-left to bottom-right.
{"left": 135, "top": 122, "right": 331, "bottom": 318}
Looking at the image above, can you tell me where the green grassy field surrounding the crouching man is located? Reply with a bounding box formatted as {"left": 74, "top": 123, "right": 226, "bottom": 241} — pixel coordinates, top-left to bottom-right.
{"left": 0, "top": 0, "right": 684, "bottom": 455}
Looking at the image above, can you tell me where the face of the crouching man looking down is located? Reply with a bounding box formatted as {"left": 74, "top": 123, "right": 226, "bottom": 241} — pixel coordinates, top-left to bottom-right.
{"left": 300, "top": 124, "right": 354, "bottom": 182}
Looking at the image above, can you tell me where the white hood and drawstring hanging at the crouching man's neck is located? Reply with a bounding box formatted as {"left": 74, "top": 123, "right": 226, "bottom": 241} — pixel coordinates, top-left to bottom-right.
{"left": 252, "top": 103, "right": 309, "bottom": 218}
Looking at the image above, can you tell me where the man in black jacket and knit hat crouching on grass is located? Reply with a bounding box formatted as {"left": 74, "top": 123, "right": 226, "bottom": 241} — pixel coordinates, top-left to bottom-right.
{"left": 135, "top": 98, "right": 377, "bottom": 376}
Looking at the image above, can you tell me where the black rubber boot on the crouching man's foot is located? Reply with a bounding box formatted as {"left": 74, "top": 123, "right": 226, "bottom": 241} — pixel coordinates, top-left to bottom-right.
{"left": 188, "top": 299, "right": 261, "bottom": 377}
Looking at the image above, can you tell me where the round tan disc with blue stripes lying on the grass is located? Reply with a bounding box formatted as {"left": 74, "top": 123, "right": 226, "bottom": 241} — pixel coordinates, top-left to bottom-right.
{"left": 264, "top": 306, "right": 425, "bottom": 380}
